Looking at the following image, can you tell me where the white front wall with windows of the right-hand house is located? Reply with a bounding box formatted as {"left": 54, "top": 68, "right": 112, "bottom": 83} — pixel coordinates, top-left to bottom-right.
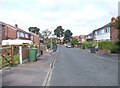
{"left": 93, "top": 24, "right": 111, "bottom": 41}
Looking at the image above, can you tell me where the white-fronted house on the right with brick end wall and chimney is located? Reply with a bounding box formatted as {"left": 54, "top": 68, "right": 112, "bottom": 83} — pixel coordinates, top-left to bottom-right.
{"left": 85, "top": 17, "right": 118, "bottom": 42}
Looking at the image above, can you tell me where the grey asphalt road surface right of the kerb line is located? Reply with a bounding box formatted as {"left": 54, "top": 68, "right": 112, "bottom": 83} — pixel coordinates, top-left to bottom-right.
{"left": 49, "top": 46, "right": 118, "bottom": 86}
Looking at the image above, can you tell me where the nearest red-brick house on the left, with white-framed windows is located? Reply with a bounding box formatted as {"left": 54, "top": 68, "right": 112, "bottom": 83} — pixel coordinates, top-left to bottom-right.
{"left": 0, "top": 22, "right": 31, "bottom": 40}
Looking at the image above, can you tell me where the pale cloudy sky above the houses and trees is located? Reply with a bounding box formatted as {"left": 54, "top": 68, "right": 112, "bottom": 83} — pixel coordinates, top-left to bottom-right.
{"left": 0, "top": 0, "right": 119, "bottom": 36}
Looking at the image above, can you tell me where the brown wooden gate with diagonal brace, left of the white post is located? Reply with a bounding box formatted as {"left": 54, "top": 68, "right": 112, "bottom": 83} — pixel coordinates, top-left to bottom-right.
{"left": 0, "top": 45, "right": 19, "bottom": 68}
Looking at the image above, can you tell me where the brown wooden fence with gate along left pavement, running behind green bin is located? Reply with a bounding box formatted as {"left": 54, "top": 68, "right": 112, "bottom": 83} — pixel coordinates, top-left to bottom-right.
{"left": 0, "top": 44, "right": 46, "bottom": 68}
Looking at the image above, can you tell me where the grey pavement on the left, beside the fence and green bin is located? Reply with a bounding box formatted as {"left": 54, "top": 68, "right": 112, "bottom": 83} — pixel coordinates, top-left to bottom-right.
{"left": 2, "top": 51, "right": 54, "bottom": 86}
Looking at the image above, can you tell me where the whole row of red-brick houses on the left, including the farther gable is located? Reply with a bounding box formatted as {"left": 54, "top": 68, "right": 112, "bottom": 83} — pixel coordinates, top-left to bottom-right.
{"left": 0, "top": 22, "right": 40, "bottom": 44}
